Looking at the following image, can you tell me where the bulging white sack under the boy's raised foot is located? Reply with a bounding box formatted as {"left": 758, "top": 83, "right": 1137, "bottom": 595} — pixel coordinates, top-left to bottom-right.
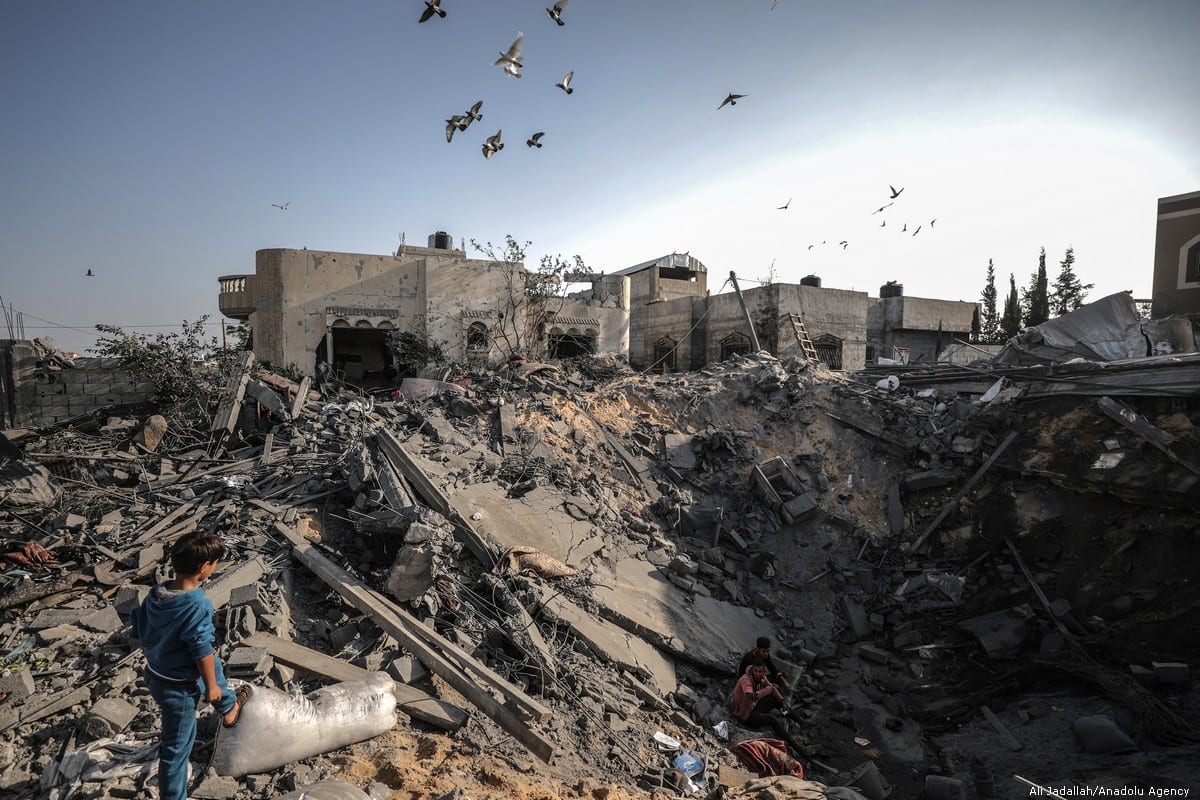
{"left": 212, "top": 672, "right": 396, "bottom": 776}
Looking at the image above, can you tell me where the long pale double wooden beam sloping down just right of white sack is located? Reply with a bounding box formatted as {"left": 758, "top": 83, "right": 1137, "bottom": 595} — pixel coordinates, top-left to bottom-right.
{"left": 275, "top": 523, "right": 554, "bottom": 764}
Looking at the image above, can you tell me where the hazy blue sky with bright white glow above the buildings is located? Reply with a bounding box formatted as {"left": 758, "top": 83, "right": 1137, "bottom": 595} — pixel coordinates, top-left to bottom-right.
{"left": 0, "top": 0, "right": 1200, "bottom": 350}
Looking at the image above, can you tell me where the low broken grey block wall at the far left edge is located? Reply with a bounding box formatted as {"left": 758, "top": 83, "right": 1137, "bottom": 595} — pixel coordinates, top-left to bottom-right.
{"left": 0, "top": 341, "right": 154, "bottom": 428}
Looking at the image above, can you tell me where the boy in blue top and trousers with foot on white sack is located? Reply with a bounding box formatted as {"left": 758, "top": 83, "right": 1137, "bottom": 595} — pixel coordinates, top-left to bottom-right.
{"left": 131, "top": 533, "right": 248, "bottom": 800}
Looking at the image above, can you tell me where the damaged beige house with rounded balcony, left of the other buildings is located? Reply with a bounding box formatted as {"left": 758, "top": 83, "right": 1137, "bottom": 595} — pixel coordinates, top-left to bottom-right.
{"left": 218, "top": 231, "right": 629, "bottom": 386}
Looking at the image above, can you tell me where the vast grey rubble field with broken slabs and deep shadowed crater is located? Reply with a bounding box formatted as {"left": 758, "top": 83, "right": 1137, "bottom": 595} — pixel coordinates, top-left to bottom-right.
{"left": 0, "top": 345, "right": 1200, "bottom": 800}
